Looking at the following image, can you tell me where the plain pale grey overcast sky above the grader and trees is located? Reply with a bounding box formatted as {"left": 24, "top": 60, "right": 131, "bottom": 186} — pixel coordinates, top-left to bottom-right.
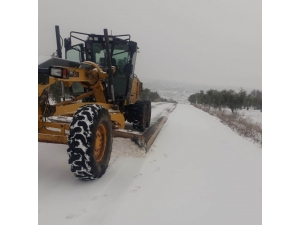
{"left": 38, "top": 0, "right": 262, "bottom": 89}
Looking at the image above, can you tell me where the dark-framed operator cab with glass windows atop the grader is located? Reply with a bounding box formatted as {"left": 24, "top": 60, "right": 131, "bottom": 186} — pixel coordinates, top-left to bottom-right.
{"left": 65, "top": 32, "right": 138, "bottom": 101}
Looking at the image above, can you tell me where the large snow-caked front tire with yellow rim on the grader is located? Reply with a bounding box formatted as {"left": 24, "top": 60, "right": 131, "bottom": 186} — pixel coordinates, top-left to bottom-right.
{"left": 67, "top": 104, "right": 113, "bottom": 180}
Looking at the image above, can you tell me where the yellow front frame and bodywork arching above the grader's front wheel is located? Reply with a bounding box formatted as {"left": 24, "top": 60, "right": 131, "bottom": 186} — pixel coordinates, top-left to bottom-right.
{"left": 38, "top": 61, "right": 125, "bottom": 144}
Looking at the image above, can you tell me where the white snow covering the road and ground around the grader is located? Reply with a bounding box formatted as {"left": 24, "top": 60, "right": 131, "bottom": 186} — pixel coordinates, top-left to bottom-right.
{"left": 38, "top": 103, "right": 262, "bottom": 225}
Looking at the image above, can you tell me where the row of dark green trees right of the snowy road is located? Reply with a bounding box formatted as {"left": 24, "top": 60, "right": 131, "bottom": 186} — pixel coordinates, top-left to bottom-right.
{"left": 188, "top": 88, "right": 262, "bottom": 112}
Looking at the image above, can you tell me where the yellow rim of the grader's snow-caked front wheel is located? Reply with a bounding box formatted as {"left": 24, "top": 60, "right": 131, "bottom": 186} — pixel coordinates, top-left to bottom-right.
{"left": 94, "top": 124, "right": 107, "bottom": 162}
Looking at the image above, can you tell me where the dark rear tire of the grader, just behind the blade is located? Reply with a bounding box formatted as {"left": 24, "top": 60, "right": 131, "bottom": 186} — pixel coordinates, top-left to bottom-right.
{"left": 133, "top": 101, "right": 147, "bottom": 132}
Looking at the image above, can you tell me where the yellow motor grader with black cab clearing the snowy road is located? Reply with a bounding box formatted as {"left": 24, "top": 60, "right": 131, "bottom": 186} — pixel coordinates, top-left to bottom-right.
{"left": 38, "top": 26, "right": 155, "bottom": 180}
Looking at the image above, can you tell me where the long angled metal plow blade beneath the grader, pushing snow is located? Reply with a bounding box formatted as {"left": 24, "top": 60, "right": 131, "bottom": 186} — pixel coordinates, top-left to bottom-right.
{"left": 113, "top": 105, "right": 176, "bottom": 152}
